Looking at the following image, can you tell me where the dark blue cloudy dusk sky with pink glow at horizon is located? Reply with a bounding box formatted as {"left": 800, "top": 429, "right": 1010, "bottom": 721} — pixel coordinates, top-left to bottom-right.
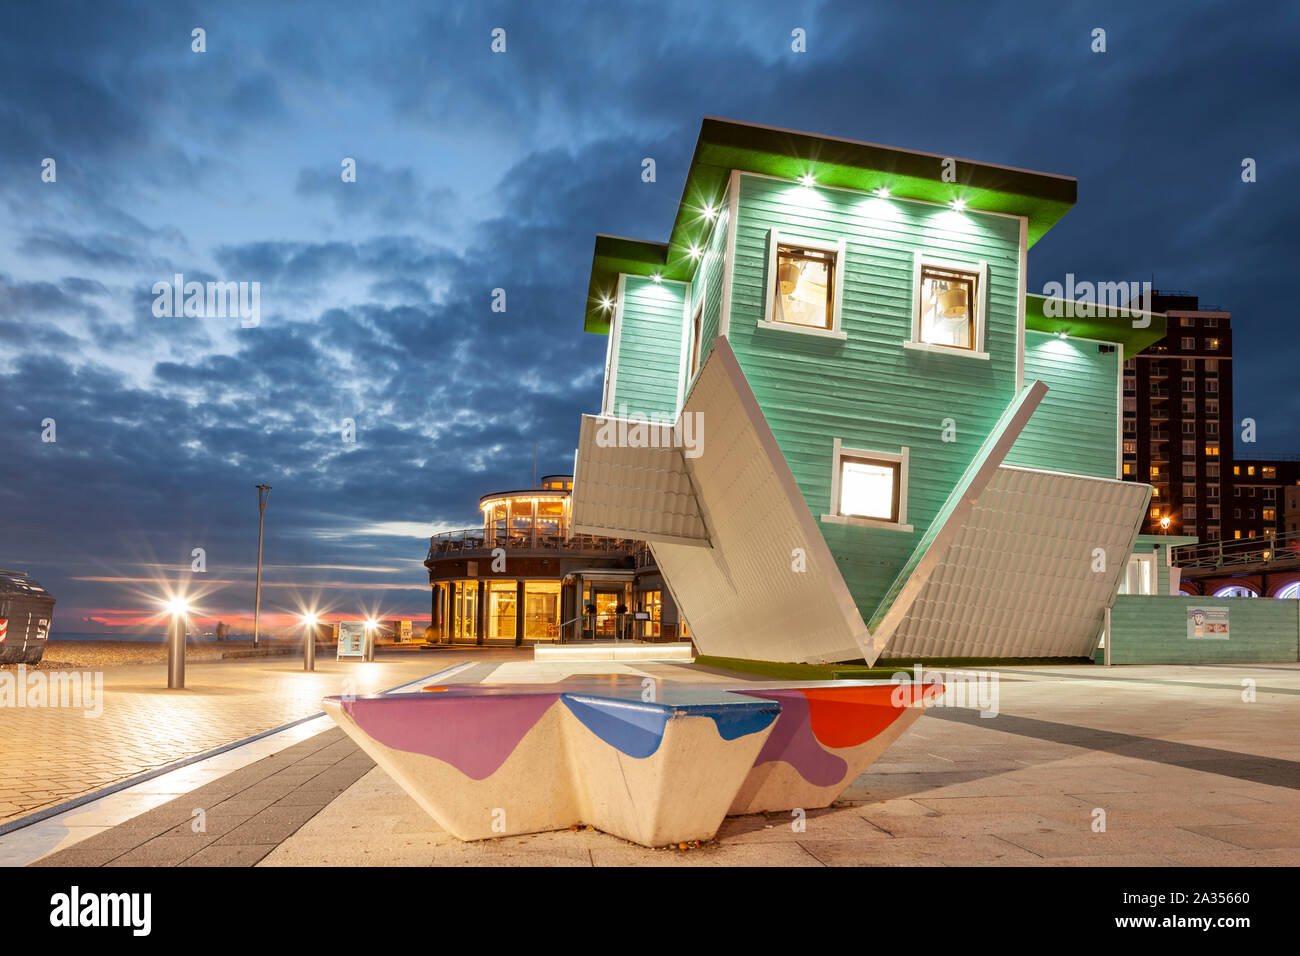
{"left": 0, "top": 0, "right": 1300, "bottom": 632}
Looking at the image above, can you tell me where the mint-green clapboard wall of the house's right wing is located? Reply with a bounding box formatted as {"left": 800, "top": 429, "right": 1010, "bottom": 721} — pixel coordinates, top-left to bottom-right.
{"left": 1006, "top": 332, "right": 1121, "bottom": 477}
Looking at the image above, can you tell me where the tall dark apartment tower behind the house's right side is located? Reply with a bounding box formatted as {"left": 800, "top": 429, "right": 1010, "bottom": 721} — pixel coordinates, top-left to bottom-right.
{"left": 1122, "top": 290, "right": 1234, "bottom": 541}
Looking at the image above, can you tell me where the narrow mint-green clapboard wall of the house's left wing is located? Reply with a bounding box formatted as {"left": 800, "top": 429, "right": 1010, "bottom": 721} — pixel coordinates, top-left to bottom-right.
{"left": 611, "top": 276, "right": 688, "bottom": 420}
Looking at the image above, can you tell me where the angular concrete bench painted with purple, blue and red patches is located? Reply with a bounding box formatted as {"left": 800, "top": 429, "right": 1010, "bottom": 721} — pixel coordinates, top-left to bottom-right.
{"left": 324, "top": 675, "right": 943, "bottom": 847}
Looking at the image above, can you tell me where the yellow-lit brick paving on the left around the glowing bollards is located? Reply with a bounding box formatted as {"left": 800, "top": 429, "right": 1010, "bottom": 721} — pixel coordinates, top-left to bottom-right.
{"left": 0, "top": 648, "right": 532, "bottom": 825}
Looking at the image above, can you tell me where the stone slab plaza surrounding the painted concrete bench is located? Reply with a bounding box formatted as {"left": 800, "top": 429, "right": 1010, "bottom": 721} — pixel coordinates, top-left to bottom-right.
{"left": 10, "top": 650, "right": 1300, "bottom": 866}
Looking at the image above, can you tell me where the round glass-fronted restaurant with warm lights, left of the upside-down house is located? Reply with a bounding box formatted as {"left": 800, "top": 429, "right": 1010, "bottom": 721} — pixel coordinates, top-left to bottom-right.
{"left": 424, "top": 475, "right": 689, "bottom": 645}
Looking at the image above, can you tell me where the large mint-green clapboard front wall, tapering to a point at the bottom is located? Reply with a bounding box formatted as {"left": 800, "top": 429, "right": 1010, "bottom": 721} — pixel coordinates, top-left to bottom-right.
{"left": 729, "top": 176, "right": 1019, "bottom": 618}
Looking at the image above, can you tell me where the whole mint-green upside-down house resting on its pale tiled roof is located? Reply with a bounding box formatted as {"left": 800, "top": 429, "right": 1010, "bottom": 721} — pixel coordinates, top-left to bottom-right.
{"left": 572, "top": 118, "right": 1165, "bottom": 663}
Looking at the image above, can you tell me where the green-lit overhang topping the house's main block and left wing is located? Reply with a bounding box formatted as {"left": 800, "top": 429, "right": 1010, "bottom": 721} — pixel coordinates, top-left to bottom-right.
{"left": 585, "top": 117, "right": 1079, "bottom": 333}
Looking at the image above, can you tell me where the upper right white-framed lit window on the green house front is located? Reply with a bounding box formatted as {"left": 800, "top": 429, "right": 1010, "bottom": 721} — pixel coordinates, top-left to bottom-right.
{"left": 911, "top": 252, "right": 988, "bottom": 356}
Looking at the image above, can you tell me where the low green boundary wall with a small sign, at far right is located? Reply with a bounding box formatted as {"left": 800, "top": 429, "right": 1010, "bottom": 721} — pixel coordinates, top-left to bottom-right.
{"left": 1110, "top": 594, "right": 1300, "bottom": 665}
